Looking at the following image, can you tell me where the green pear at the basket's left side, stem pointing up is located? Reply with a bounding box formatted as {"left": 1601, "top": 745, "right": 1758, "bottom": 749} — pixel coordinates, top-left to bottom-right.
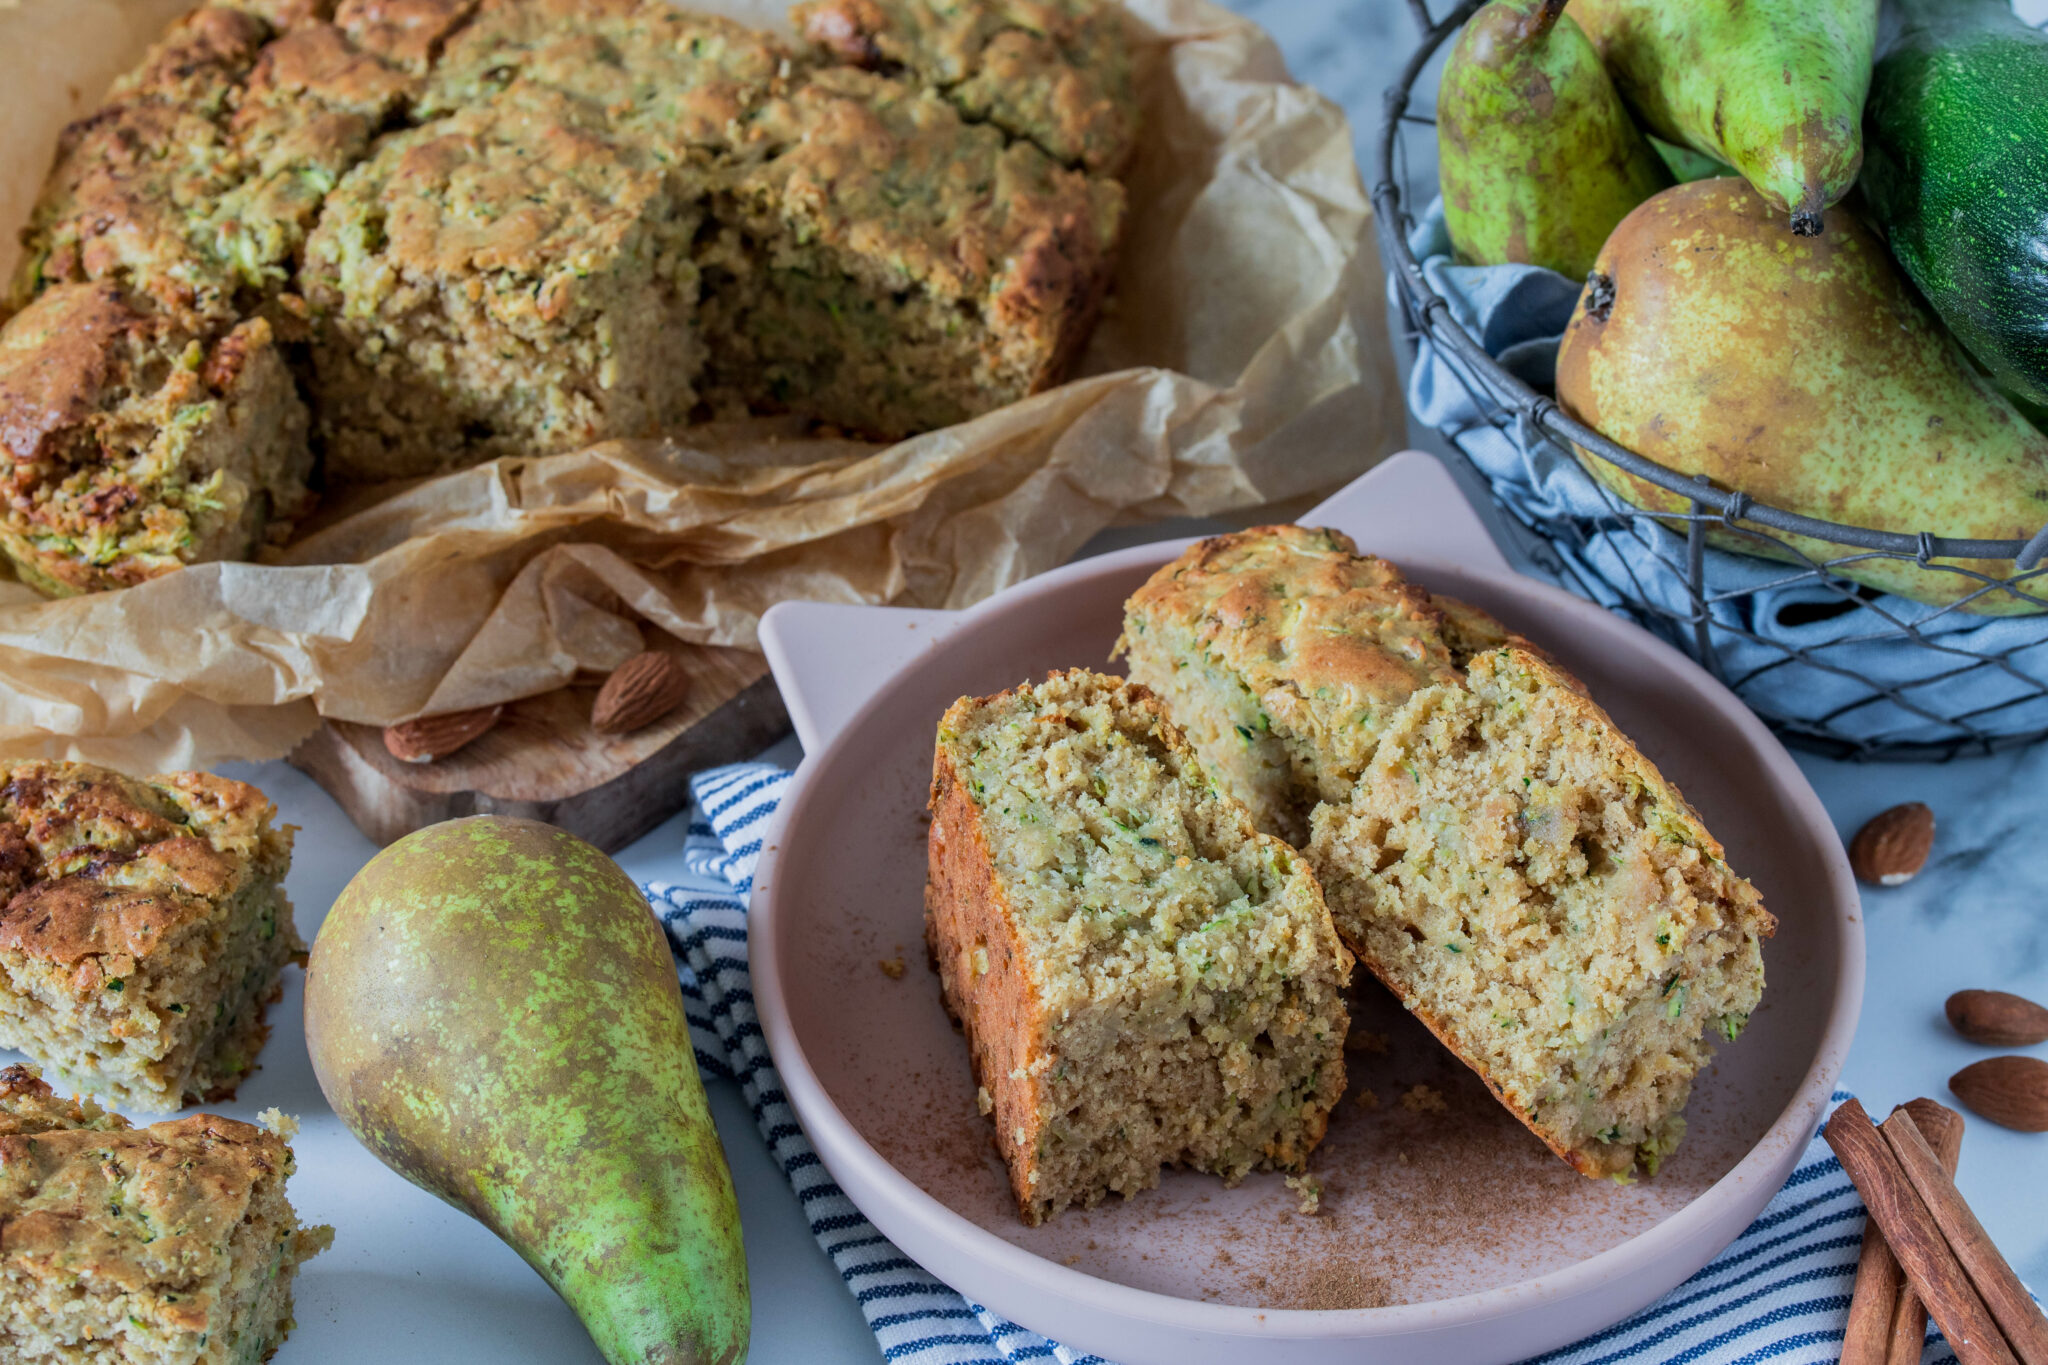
{"left": 1436, "top": 0, "right": 1671, "bottom": 280}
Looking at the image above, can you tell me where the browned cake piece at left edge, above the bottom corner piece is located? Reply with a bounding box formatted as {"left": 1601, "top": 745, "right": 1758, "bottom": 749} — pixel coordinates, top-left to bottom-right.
{"left": 0, "top": 761, "right": 305, "bottom": 1111}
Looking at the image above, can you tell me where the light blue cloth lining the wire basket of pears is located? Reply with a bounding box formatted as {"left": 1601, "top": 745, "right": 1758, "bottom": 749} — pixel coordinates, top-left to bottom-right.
{"left": 1389, "top": 201, "right": 2048, "bottom": 743}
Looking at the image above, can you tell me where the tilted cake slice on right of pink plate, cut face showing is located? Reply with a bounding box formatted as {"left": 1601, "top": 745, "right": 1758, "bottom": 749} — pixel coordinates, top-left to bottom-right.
{"left": 1309, "top": 647, "right": 1776, "bottom": 1175}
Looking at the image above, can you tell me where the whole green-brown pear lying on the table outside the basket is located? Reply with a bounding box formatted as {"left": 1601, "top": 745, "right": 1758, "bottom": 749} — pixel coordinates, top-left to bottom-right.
{"left": 305, "top": 817, "right": 750, "bottom": 1365}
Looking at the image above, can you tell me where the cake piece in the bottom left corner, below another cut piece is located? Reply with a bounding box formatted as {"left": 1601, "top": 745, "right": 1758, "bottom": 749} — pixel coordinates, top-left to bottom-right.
{"left": 0, "top": 1066, "right": 334, "bottom": 1365}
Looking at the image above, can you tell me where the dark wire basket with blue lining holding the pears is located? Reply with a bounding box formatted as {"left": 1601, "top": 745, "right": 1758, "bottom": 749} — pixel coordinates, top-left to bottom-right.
{"left": 1372, "top": 0, "right": 2048, "bottom": 759}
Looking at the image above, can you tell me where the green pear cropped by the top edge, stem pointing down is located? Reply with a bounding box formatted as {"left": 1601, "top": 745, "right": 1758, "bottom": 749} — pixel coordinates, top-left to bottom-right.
{"left": 1571, "top": 0, "right": 1878, "bottom": 235}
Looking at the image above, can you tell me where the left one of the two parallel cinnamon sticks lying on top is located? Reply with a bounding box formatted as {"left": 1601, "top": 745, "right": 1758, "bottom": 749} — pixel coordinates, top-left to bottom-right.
{"left": 1825, "top": 1099, "right": 2019, "bottom": 1365}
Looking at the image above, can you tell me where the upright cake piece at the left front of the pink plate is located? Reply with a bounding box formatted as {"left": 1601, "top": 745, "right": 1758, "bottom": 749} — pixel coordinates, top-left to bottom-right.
{"left": 926, "top": 671, "right": 1352, "bottom": 1224}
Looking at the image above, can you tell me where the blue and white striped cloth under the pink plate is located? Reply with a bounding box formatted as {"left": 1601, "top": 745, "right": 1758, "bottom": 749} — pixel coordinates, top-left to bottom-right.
{"left": 645, "top": 763, "right": 1956, "bottom": 1365}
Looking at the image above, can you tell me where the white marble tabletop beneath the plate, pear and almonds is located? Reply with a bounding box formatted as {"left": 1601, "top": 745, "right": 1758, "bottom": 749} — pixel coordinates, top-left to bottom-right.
{"left": 4, "top": 0, "right": 2048, "bottom": 1365}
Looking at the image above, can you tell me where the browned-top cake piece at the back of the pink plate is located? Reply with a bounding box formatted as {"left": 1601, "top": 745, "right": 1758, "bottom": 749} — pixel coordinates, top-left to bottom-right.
{"left": 1116, "top": 526, "right": 1466, "bottom": 845}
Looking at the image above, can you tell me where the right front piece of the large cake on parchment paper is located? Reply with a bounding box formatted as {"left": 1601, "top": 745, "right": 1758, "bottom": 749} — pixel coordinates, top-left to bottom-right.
{"left": 702, "top": 68, "right": 1124, "bottom": 440}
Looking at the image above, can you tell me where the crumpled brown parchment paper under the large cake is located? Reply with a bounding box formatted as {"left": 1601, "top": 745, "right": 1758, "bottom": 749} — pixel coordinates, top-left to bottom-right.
{"left": 0, "top": 0, "right": 1403, "bottom": 769}
